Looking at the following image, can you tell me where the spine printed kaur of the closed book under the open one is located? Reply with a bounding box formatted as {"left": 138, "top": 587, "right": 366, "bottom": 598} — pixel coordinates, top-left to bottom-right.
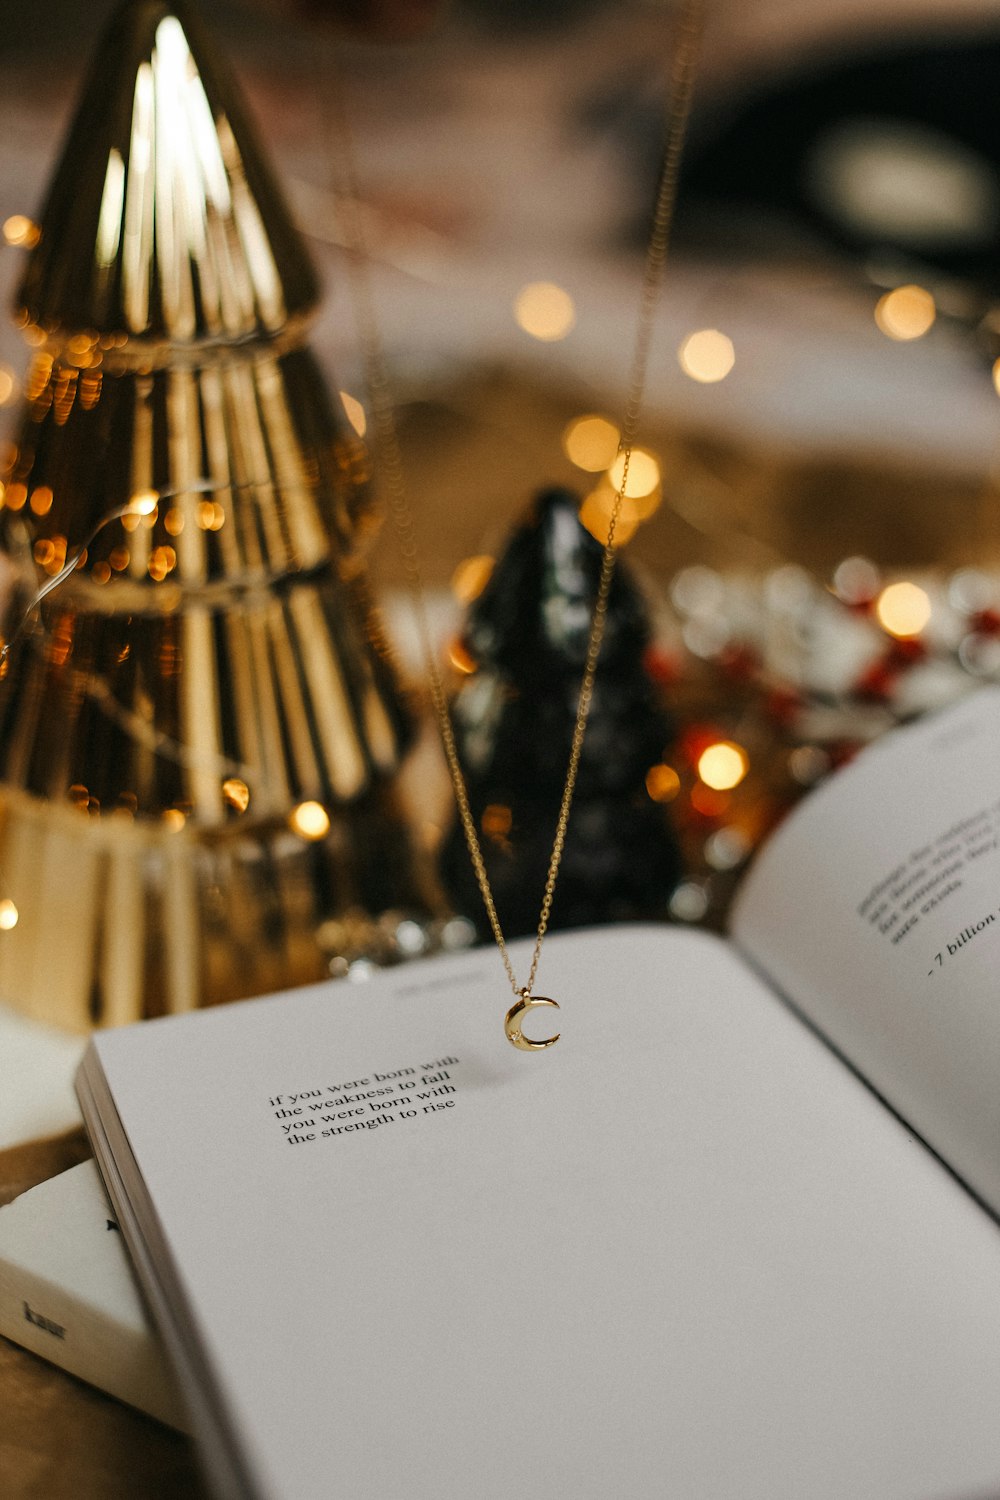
{"left": 0, "top": 1260, "right": 187, "bottom": 1431}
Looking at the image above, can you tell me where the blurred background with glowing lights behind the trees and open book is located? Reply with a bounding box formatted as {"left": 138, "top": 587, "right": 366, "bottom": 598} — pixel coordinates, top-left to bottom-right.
{"left": 0, "top": 0, "right": 1000, "bottom": 960}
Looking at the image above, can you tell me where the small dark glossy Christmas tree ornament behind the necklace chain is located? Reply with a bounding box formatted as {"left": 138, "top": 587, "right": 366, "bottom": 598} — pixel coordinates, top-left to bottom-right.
{"left": 441, "top": 489, "right": 681, "bottom": 936}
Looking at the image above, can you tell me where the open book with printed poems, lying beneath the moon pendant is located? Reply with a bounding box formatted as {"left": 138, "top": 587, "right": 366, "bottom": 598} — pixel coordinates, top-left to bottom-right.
{"left": 78, "top": 693, "right": 1000, "bottom": 1500}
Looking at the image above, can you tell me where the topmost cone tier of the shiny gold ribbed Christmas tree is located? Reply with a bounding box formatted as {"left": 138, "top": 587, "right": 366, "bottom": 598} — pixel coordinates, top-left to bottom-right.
{"left": 19, "top": 0, "right": 318, "bottom": 349}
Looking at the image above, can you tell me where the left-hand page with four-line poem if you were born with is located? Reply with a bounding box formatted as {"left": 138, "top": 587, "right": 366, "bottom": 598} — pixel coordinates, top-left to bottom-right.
{"left": 84, "top": 929, "right": 1000, "bottom": 1500}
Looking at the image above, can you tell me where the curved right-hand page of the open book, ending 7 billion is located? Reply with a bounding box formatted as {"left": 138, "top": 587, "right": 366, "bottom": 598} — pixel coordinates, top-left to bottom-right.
{"left": 732, "top": 690, "right": 1000, "bottom": 1215}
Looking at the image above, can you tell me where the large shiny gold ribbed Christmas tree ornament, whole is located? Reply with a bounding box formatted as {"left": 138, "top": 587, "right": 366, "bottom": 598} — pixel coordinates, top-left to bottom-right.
{"left": 0, "top": 0, "right": 426, "bottom": 1026}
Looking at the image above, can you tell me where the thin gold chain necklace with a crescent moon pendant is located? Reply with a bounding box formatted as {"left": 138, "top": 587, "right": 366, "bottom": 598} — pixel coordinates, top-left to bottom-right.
{"left": 324, "top": 0, "right": 705, "bottom": 1052}
